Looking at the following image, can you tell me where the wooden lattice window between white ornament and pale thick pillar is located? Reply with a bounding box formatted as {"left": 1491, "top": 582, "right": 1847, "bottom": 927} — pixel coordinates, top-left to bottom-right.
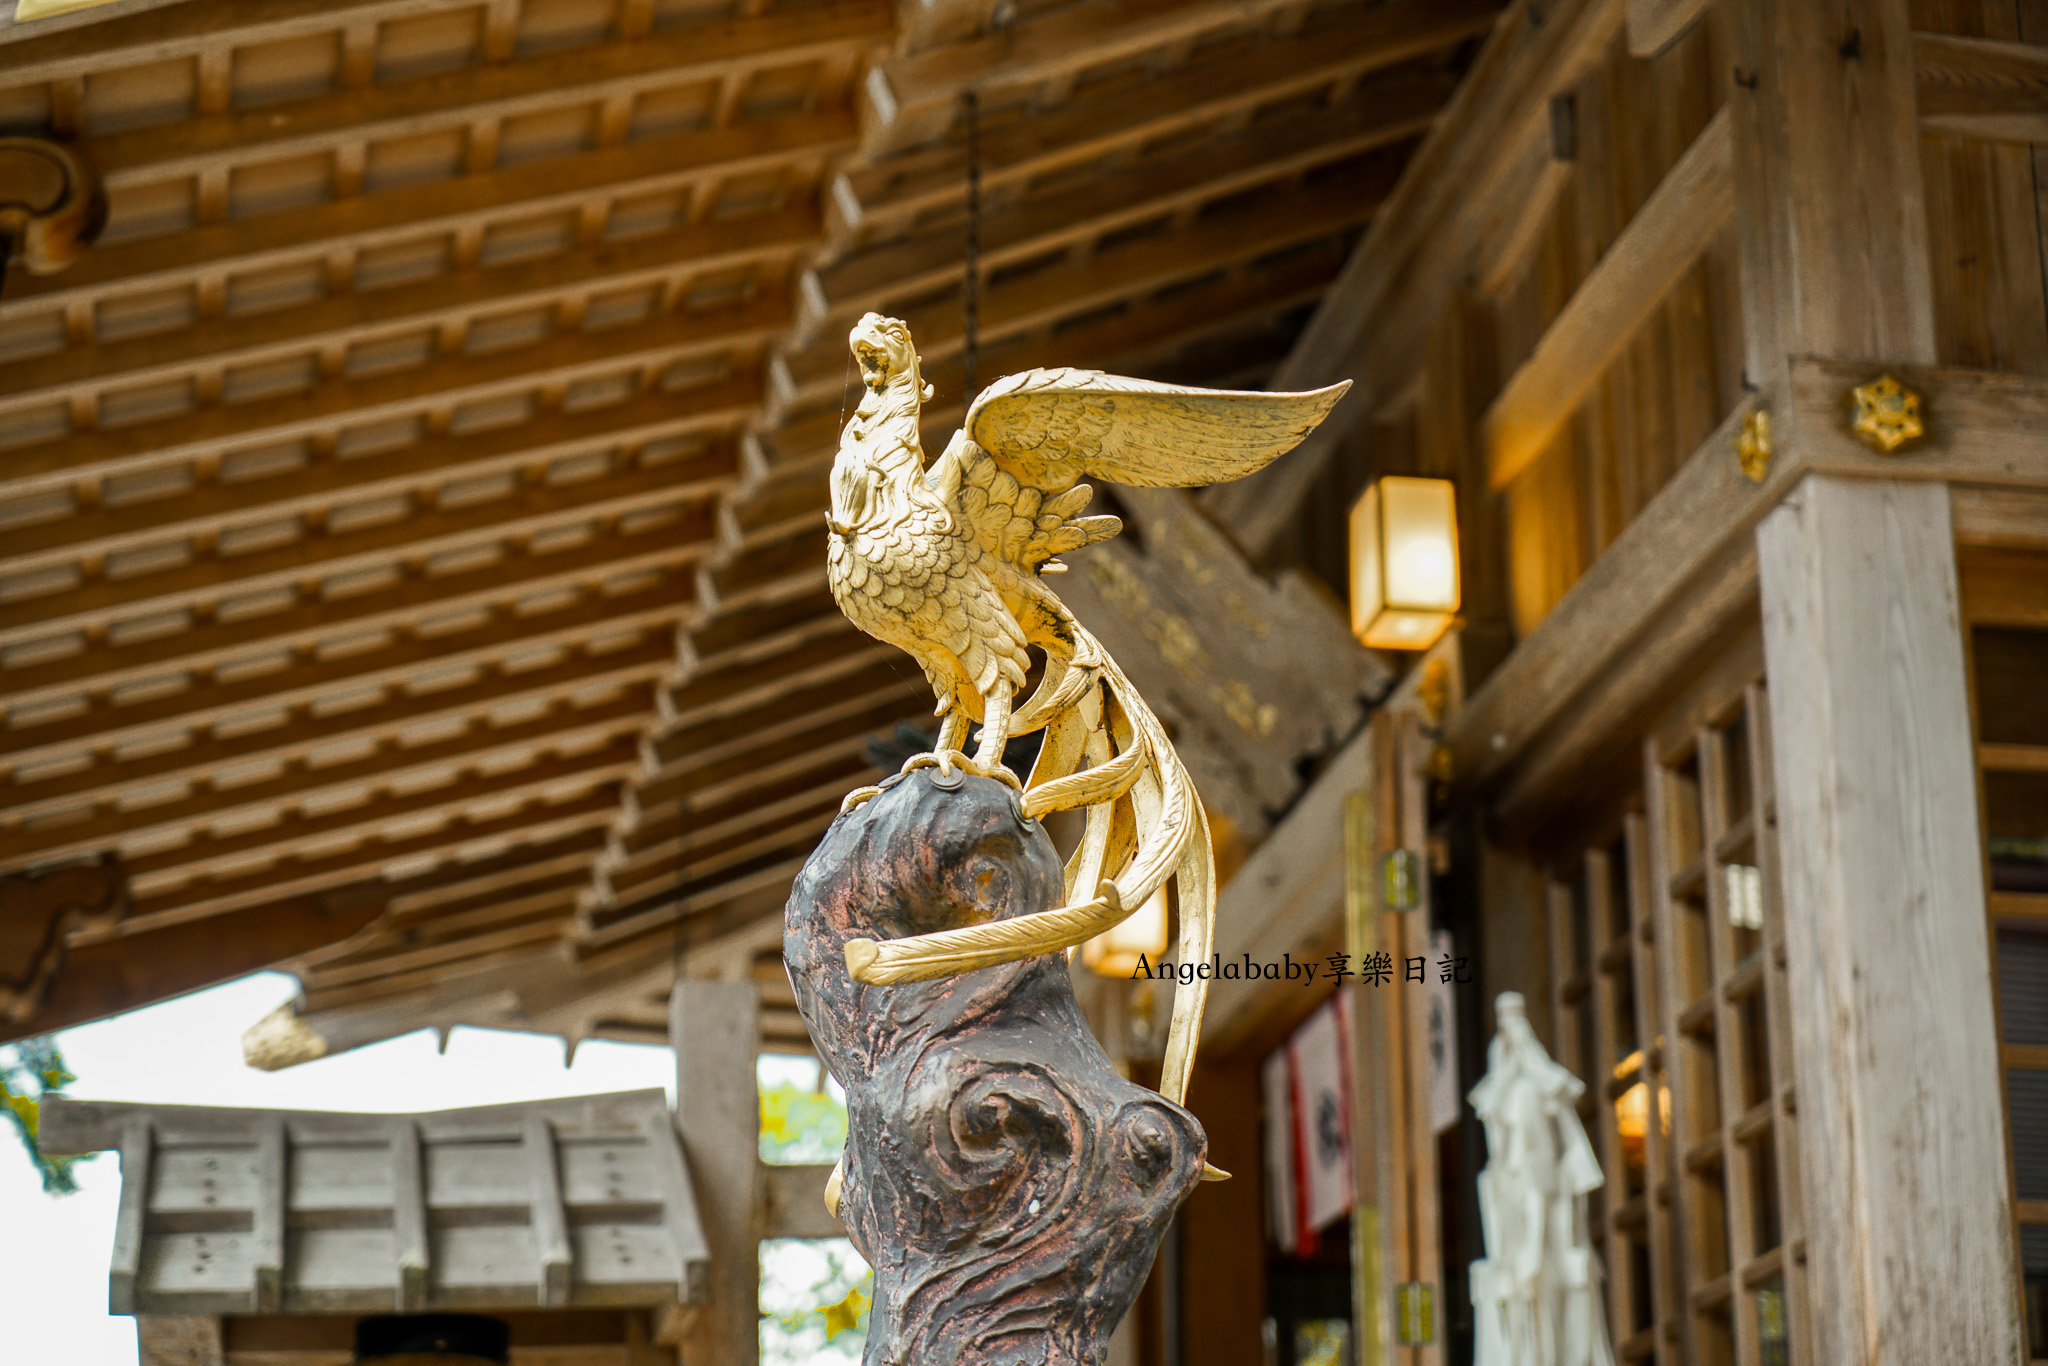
{"left": 1548, "top": 651, "right": 1812, "bottom": 1366}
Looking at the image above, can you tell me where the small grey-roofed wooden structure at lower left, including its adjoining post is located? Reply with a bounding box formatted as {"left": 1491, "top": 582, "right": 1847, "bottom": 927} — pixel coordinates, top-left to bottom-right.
{"left": 41, "top": 983, "right": 840, "bottom": 1366}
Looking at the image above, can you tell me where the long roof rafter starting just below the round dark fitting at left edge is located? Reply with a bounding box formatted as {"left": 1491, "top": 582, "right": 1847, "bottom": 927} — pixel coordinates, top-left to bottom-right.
{"left": 0, "top": 109, "right": 854, "bottom": 322}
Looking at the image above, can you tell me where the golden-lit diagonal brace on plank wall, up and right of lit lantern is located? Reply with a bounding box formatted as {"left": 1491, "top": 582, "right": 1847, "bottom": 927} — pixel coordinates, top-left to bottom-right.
{"left": 1485, "top": 111, "right": 1735, "bottom": 489}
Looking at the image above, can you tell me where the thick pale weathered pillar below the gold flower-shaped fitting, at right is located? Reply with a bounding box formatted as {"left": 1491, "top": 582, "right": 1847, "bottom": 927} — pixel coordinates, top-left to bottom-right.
{"left": 1757, "top": 475, "right": 2021, "bottom": 1366}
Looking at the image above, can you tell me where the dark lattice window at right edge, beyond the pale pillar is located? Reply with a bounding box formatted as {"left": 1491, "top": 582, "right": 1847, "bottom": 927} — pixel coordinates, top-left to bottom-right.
{"left": 1962, "top": 555, "right": 2048, "bottom": 1364}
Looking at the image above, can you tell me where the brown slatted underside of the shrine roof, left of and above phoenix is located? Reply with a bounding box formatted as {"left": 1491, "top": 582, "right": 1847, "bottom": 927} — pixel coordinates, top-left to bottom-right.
{"left": 0, "top": 0, "right": 1499, "bottom": 1061}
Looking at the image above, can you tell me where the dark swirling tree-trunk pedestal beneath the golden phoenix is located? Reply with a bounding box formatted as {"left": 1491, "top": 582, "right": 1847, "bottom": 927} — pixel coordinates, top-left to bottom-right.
{"left": 782, "top": 768, "right": 1208, "bottom": 1366}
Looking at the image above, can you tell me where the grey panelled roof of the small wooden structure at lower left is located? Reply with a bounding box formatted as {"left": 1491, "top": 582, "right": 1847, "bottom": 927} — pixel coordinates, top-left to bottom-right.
{"left": 43, "top": 1092, "right": 711, "bottom": 1317}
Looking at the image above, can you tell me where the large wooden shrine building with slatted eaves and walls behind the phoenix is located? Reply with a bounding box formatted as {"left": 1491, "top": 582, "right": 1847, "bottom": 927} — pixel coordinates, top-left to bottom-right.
{"left": 0, "top": 0, "right": 2048, "bottom": 1366}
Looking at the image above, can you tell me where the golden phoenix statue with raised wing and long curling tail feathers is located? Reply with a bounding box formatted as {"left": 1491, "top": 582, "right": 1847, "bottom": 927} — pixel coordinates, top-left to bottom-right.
{"left": 825, "top": 313, "right": 1350, "bottom": 1102}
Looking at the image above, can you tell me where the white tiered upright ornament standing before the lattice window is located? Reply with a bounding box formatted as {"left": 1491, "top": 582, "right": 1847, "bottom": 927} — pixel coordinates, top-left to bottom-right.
{"left": 1468, "top": 991, "right": 1614, "bottom": 1366}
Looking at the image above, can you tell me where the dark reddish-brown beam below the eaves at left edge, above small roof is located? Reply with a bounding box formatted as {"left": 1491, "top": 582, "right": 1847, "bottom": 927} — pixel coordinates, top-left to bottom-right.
{"left": 0, "top": 879, "right": 389, "bottom": 1040}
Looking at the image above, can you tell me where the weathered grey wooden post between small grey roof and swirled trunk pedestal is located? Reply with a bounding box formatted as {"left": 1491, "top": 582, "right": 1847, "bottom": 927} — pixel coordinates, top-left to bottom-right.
{"left": 668, "top": 979, "right": 762, "bottom": 1366}
